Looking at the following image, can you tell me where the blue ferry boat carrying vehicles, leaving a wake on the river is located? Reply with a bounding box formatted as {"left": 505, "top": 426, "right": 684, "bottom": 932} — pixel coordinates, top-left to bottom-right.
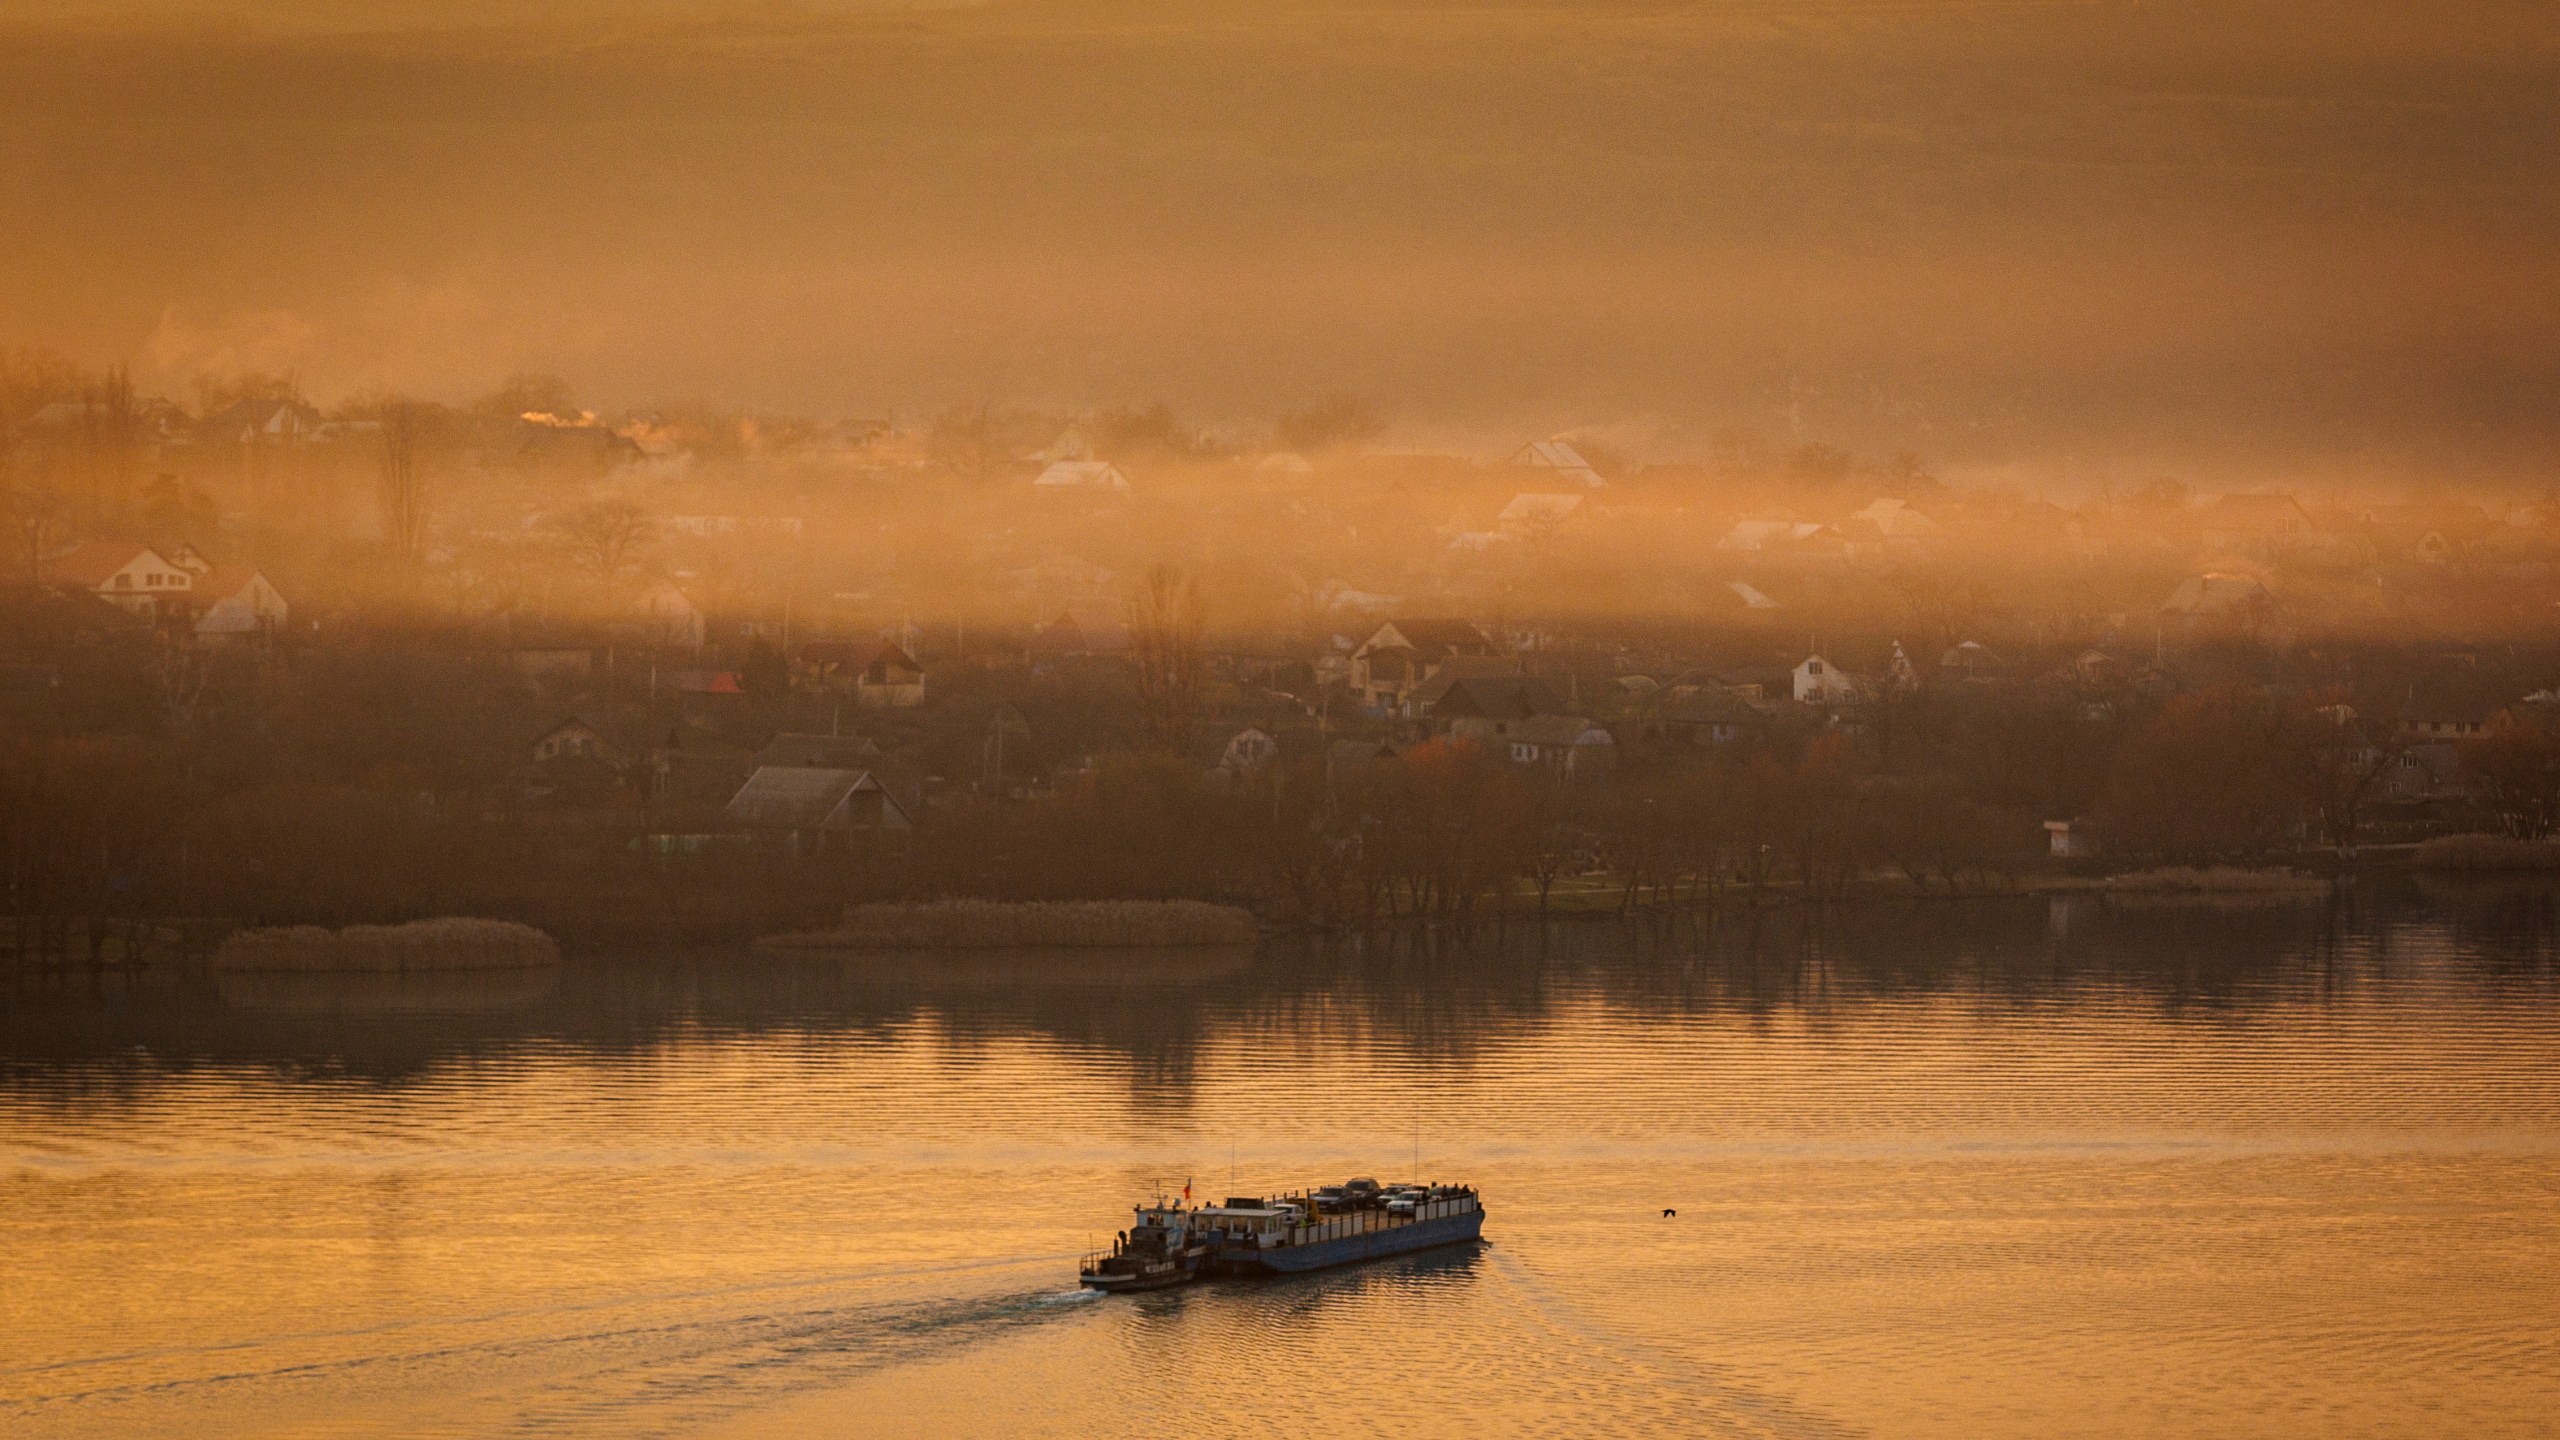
{"left": 1078, "top": 1179, "right": 1485, "bottom": 1289}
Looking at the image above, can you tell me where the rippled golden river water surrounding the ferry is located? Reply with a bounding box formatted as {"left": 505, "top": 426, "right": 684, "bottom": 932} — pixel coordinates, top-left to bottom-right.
{"left": 0, "top": 881, "right": 2560, "bottom": 1437}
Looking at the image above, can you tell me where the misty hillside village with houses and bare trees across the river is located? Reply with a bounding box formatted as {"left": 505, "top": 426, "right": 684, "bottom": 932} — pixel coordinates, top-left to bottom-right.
{"left": 0, "top": 366, "right": 2560, "bottom": 943}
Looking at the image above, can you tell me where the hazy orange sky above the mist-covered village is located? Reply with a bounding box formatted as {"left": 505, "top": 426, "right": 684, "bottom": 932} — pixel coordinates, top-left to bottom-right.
{"left": 0, "top": 0, "right": 2560, "bottom": 482}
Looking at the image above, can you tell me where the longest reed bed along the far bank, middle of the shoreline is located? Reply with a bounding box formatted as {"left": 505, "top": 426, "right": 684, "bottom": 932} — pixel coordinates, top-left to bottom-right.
{"left": 763, "top": 899, "right": 1260, "bottom": 951}
